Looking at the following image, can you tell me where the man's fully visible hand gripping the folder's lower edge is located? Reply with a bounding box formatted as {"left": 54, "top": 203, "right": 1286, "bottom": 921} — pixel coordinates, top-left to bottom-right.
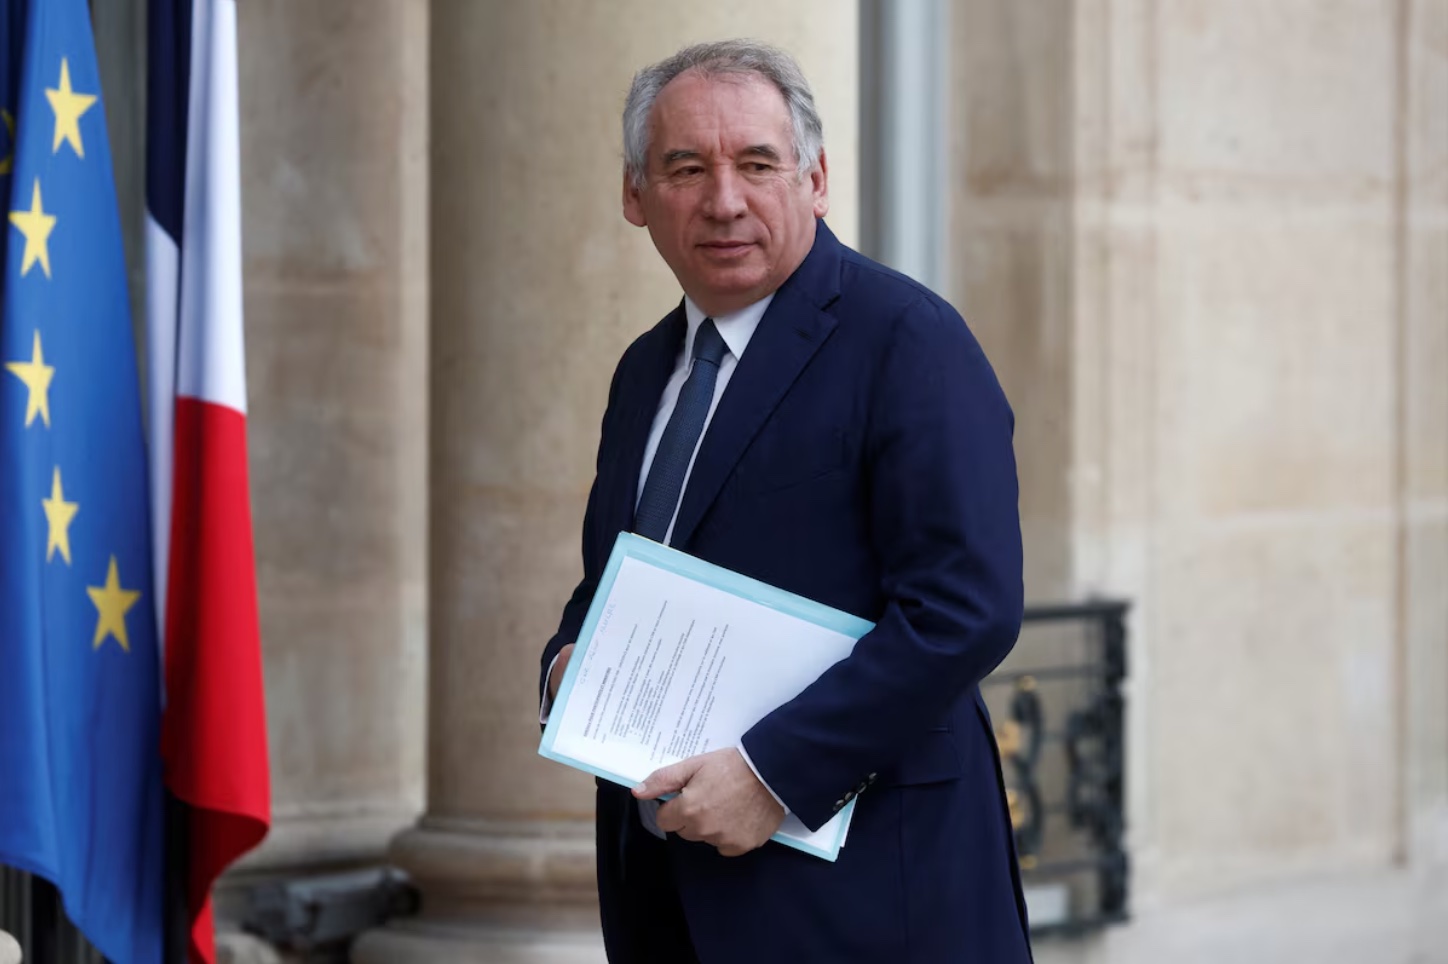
{"left": 633, "top": 747, "right": 785, "bottom": 857}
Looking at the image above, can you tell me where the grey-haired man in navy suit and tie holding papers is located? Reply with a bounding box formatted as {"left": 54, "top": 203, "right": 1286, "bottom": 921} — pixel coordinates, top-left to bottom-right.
{"left": 542, "top": 42, "right": 1030, "bottom": 964}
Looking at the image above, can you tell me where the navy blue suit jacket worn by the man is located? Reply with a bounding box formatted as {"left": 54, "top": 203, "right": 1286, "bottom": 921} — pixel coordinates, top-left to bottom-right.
{"left": 542, "top": 221, "right": 1030, "bottom": 964}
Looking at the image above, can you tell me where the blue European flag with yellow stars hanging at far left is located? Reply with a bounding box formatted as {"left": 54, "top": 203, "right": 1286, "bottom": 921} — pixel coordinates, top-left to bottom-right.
{"left": 0, "top": 0, "right": 165, "bottom": 964}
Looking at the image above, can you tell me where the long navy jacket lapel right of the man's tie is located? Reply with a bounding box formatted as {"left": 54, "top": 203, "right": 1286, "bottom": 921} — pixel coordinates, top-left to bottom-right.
{"left": 670, "top": 221, "right": 840, "bottom": 547}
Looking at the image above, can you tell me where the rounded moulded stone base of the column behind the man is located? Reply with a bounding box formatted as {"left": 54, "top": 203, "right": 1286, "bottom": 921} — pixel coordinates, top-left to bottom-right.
{"left": 352, "top": 816, "right": 605, "bottom": 964}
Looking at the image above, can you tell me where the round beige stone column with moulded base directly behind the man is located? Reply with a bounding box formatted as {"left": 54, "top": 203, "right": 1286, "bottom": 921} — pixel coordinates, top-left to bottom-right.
{"left": 353, "top": 0, "right": 857, "bottom": 964}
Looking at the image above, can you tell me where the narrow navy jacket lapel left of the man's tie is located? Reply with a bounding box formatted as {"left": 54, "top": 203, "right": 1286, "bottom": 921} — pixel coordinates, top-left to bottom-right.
{"left": 604, "top": 303, "right": 688, "bottom": 541}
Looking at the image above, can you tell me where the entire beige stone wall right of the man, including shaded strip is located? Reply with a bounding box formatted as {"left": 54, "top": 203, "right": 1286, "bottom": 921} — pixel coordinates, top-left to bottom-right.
{"left": 954, "top": 0, "right": 1448, "bottom": 926}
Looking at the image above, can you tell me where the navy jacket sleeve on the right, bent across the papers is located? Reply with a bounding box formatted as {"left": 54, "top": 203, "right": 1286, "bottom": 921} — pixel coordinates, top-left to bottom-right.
{"left": 743, "top": 298, "right": 1024, "bottom": 829}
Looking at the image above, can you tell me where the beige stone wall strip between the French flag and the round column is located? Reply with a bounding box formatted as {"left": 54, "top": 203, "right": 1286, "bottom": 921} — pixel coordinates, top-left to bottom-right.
{"left": 237, "top": 0, "right": 427, "bottom": 867}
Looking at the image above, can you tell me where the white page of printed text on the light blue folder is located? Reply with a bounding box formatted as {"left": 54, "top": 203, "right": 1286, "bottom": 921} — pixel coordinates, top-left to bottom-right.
{"left": 543, "top": 550, "right": 869, "bottom": 858}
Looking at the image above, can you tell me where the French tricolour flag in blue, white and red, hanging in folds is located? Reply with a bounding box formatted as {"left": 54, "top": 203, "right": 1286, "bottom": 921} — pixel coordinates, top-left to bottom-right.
{"left": 146, "top": 0, "right": 271, "bottom": 964}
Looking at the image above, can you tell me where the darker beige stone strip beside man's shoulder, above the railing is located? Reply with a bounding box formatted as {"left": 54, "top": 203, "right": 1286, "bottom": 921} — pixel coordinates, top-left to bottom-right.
{"left": 944, "top": 0, "right": 1074, "bottom": 602}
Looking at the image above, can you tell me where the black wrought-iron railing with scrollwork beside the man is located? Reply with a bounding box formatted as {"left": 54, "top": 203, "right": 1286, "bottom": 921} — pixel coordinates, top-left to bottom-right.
{"left": 980, "top": 601, "right": 1131, "bottom": 935}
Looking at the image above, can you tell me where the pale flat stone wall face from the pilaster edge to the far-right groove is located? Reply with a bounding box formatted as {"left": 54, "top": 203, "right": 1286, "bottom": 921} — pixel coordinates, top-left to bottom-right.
{"left": 1077, "top": 3, "right": 1400, "bottom": 892}
